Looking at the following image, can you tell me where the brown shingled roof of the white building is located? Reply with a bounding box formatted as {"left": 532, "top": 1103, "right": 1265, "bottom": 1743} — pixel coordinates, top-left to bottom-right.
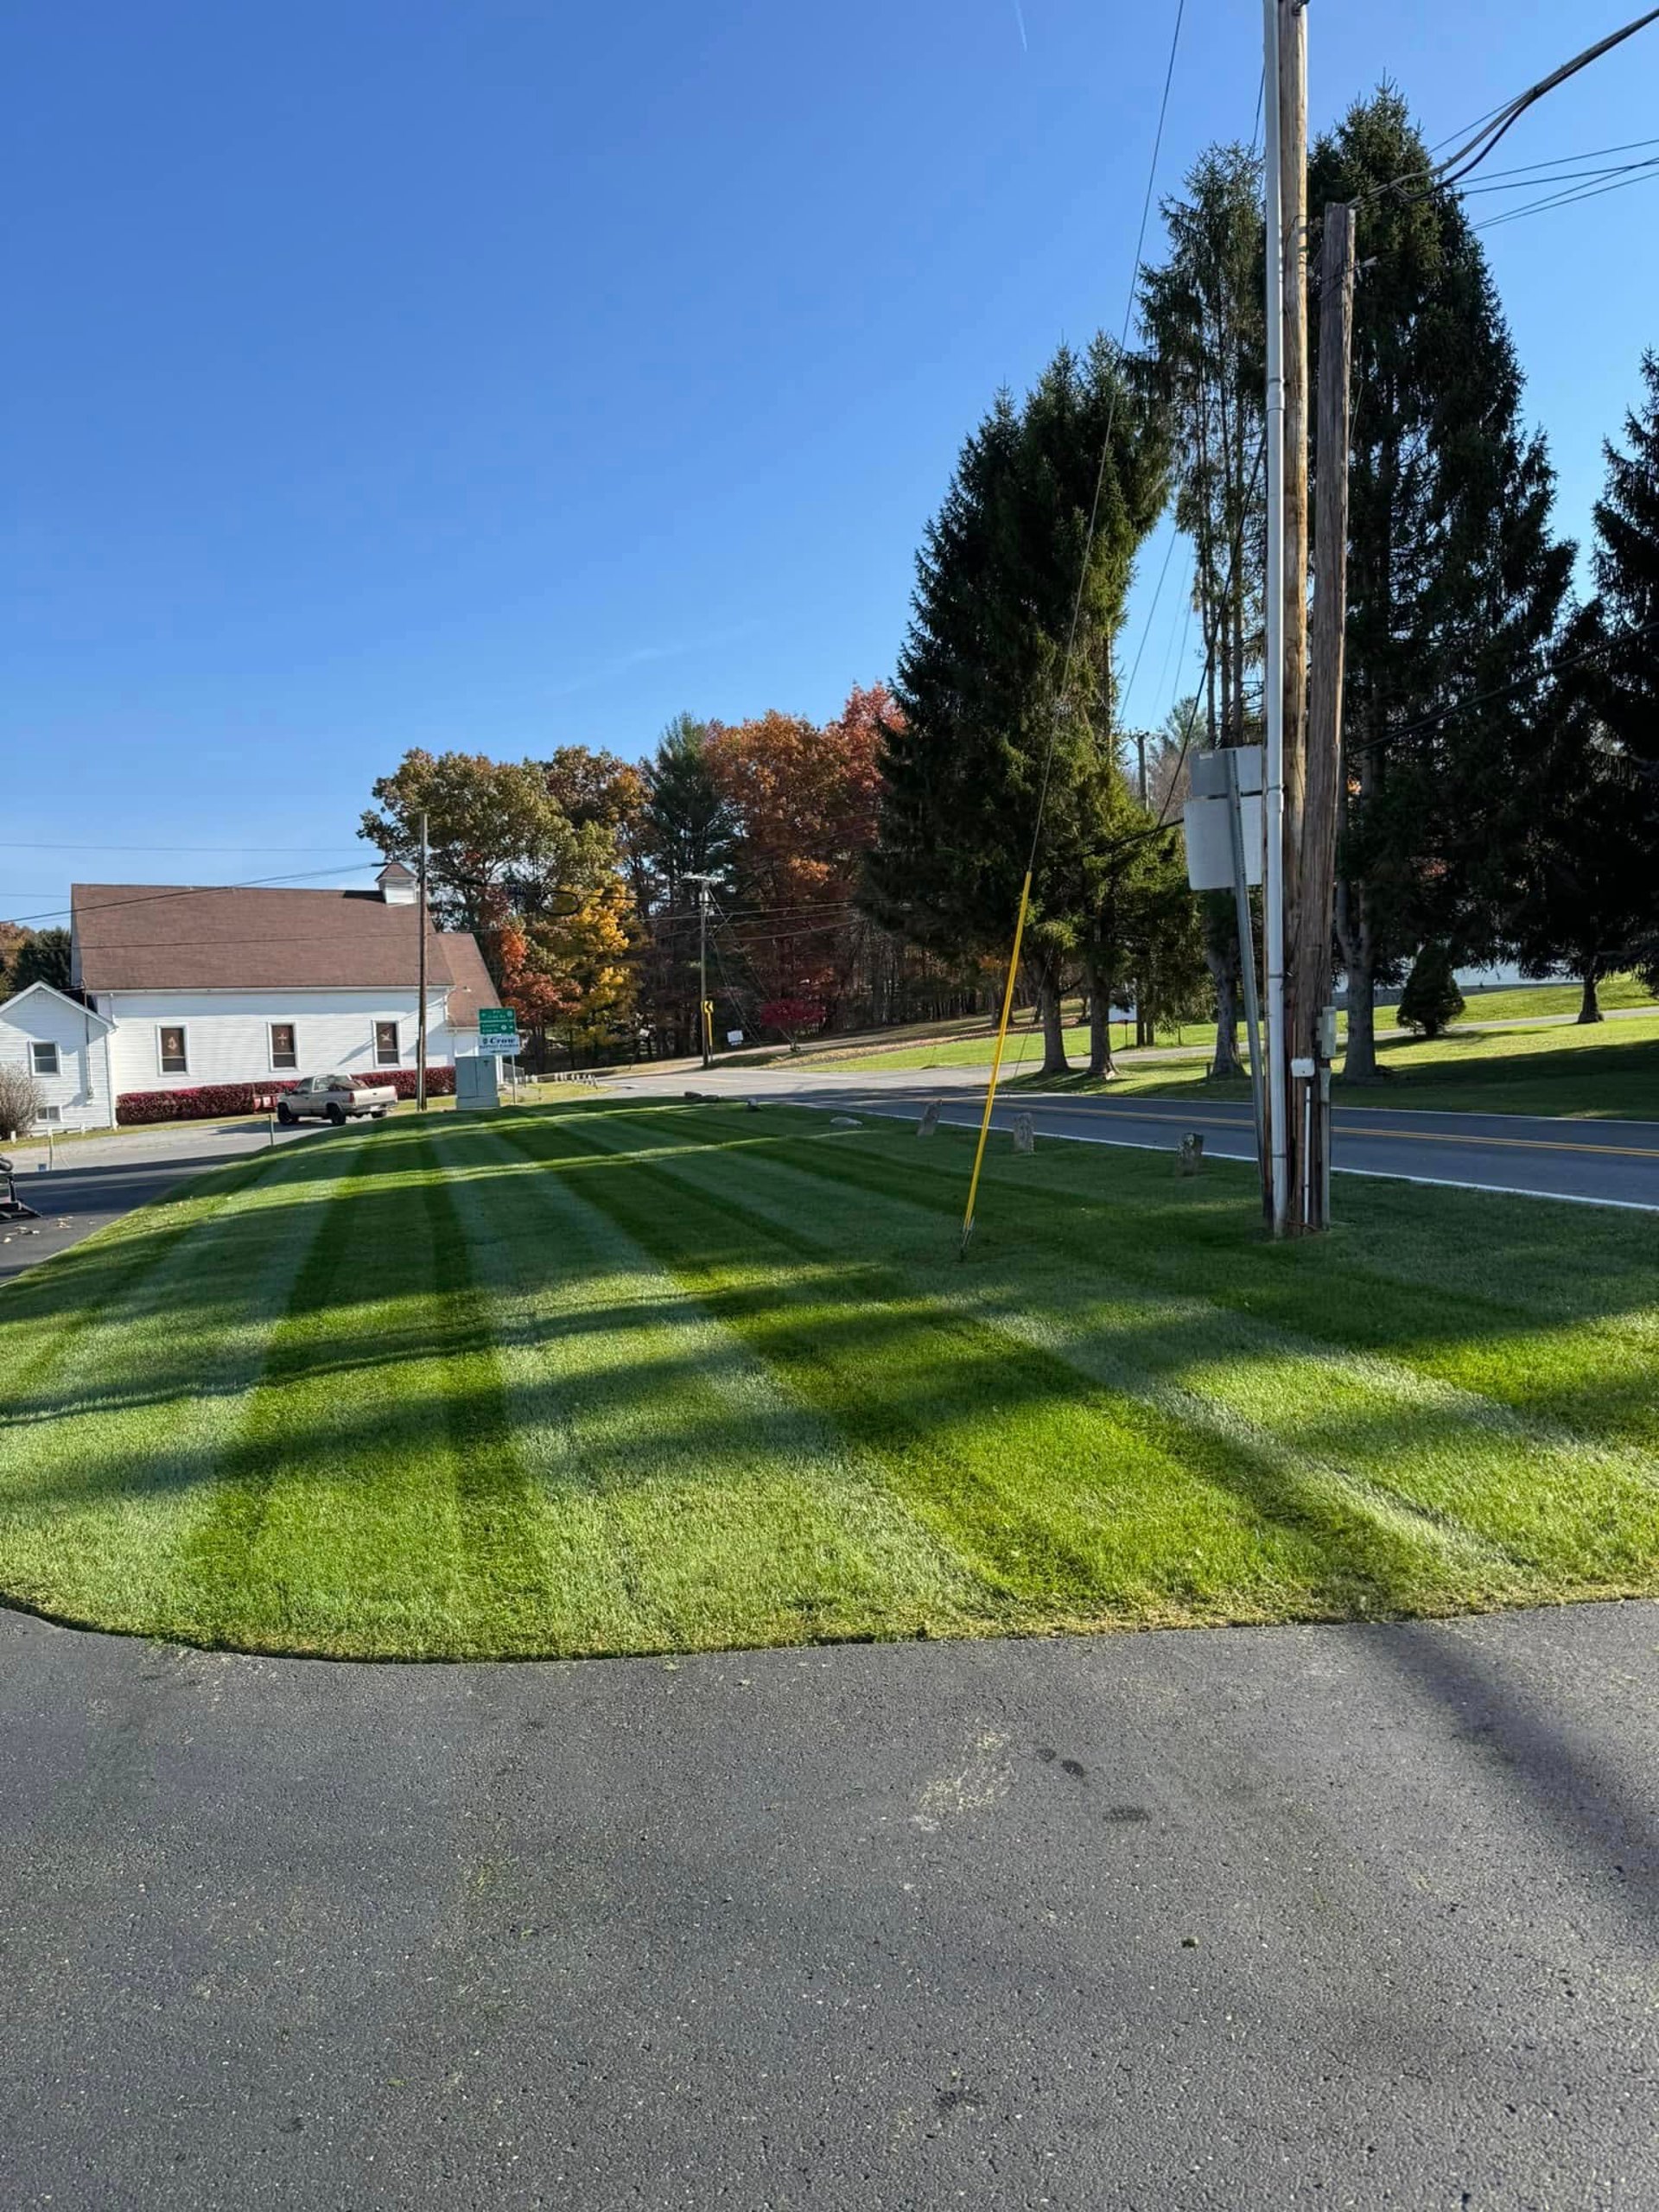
{"left": 68, "top": 882, "right": 495, "bottom": 1024}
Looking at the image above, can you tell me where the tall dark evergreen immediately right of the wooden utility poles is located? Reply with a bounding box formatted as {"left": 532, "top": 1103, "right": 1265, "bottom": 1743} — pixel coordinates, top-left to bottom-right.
{"left": 1310, "top": 88, "right": 1573, "bottom": 1082}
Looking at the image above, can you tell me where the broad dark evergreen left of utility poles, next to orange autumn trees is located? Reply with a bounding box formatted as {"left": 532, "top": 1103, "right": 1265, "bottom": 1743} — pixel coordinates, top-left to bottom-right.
{"left": 862, "top": 339, "right": 1168, "bottom": 1073}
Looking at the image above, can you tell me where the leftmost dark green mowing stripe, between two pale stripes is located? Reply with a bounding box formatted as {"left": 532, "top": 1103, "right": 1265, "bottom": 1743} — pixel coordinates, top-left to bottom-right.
{"left": 194, "top": 1122, "right": 553, "bottom": 1656}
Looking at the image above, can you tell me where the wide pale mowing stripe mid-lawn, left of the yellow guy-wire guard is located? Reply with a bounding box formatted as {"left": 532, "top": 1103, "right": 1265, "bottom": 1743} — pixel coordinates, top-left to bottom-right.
{"left": 442, "top": 1123, "right": 995, "bottom": 1650}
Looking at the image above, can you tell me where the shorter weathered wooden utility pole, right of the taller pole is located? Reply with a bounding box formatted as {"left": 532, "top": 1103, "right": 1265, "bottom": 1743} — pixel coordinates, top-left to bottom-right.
{"left": 1285, "top": 206, "right": 1354, "bottom": 1230}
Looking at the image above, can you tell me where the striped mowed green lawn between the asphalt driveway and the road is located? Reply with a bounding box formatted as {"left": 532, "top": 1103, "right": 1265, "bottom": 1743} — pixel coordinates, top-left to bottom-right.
{"left": 0, "top": 1102, "right": 1659, "bottom": 1656}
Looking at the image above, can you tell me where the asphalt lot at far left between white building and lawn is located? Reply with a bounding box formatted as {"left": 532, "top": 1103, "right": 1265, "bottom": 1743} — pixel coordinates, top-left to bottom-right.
{"left": 0, "top": 1122, "right": 321, "bottom": 1283}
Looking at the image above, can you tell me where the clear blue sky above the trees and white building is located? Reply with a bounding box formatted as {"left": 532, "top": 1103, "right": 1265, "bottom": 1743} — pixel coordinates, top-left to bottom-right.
{"left": 0, "top": 0, "right": 1659, "bottom": 916}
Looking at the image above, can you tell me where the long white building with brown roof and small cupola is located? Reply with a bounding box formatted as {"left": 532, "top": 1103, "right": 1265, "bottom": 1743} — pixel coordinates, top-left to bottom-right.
{"left": 0, "top": 861, "right": 498, "bottom": 1128}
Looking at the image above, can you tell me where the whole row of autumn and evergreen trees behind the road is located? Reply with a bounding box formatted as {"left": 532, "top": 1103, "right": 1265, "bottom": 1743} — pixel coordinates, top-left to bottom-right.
{"left": 363, "top": 88, "right": 1659, "bottom": 1079}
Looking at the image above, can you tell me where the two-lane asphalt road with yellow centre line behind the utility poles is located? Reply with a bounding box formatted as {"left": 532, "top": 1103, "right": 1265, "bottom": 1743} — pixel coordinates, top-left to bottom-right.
{"left": 608, "top": 1068, "right": 1659, "bottom": 1212}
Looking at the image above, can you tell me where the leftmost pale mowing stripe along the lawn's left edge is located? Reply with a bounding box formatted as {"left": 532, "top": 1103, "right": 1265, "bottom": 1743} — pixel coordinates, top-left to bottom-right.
{"left": 0, "top": 1146, "right": 362, "bottom": 1635}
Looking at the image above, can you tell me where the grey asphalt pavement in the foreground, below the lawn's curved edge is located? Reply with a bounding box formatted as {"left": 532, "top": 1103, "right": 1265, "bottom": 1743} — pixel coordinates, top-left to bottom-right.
{"left": 0, "top": 1604, "right": 1659, "bottom": 2212}
